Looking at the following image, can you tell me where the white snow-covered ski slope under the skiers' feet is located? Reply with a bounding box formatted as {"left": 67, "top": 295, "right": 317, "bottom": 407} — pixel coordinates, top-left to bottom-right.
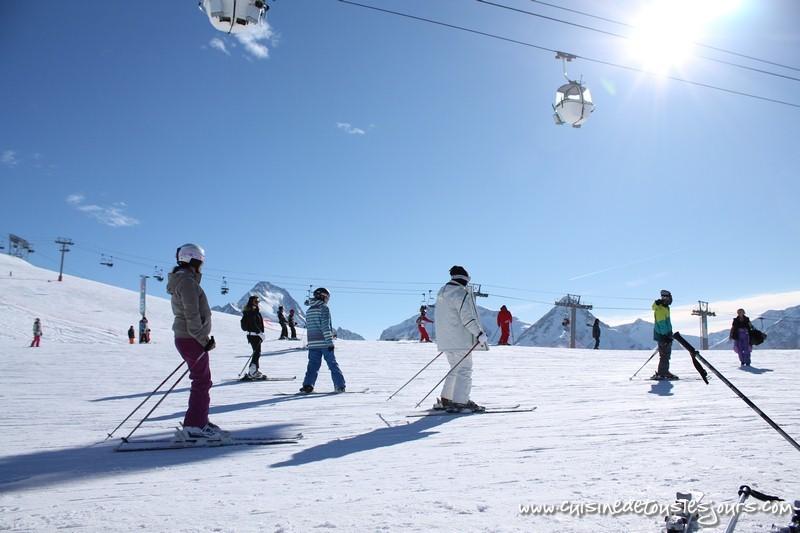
{"left": 0, "top": 257, "right": 800, "bottom": 533}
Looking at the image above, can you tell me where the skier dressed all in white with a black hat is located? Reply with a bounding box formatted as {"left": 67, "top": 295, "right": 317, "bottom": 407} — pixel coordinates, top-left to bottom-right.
{"left": 434, "top": 266, "right": 489, "bottom": 412}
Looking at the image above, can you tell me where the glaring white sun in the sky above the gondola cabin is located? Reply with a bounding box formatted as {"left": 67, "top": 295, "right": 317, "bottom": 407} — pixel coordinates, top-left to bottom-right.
{"left": 630, "top": 0, "right": 741, "bottom": 74}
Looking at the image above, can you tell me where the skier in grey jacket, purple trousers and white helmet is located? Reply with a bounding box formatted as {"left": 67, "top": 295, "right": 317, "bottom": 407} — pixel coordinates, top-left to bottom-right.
{"left": 167, "top": 244, "right": 227, "bottom": 440}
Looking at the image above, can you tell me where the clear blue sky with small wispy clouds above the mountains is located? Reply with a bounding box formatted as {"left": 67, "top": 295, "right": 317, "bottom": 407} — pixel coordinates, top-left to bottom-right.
{"left": 0, "top": 0, "right": 800, "bottom": 337}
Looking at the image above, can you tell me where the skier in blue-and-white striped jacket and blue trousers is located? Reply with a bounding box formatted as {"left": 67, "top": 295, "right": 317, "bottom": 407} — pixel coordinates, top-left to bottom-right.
{"left": 300, "top": 287, "right": 345, "bottom": 394}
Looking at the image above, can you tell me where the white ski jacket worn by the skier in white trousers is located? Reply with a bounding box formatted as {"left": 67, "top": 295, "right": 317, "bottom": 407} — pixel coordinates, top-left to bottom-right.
{"left": 435, "top": 281, "right": 489, "bottom": 352}
